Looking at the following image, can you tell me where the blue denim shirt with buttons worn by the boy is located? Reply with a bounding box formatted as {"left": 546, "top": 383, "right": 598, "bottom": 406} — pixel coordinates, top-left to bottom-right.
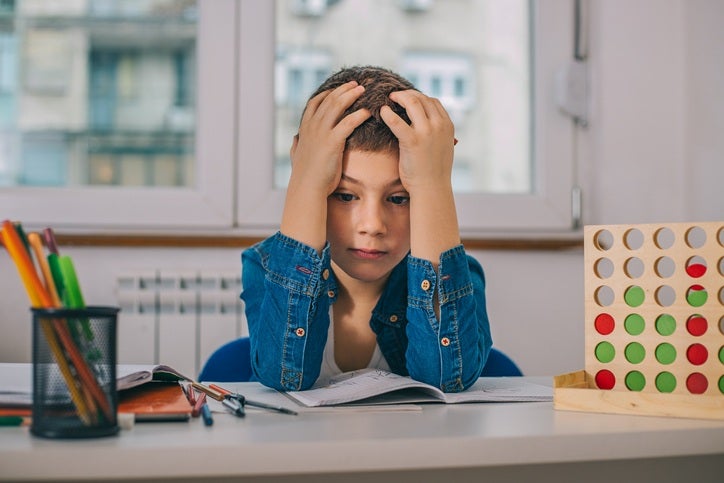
{"left": 241, "top": 232, "right": 492, "bottom": 392}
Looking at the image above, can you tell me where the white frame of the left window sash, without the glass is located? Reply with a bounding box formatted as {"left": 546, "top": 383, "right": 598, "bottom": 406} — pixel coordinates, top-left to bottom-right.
{"left": 0, "top": 0, "right": 239, "bottom": 233}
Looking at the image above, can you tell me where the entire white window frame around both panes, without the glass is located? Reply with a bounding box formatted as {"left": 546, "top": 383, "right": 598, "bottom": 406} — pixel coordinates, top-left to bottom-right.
{"left": 0, "top": 0, "right": 576, "bottom": 239}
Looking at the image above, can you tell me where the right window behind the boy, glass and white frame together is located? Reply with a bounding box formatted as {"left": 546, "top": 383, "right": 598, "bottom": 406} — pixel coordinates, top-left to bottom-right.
{"left": 237, "top": 0, "right": 574, "bottom": 236}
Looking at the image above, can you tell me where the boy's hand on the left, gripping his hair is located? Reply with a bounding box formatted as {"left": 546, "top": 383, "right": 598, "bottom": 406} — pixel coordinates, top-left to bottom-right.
{"left": 290, "top": 81, "right": 370, "bottom": 197}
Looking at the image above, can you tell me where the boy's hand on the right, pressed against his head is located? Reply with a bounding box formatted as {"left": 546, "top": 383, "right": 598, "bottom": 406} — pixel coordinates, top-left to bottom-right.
{"left": 380, "top": 90, "right": 455, "bottom": 194}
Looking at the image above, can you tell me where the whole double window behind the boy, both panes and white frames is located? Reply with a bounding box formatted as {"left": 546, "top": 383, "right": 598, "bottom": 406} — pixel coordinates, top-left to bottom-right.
{"left": 0, "top": 0, "right": 574, "bottom": 237}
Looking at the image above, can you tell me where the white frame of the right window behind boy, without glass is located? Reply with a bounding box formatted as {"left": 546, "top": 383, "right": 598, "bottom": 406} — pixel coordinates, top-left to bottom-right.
{"left": 236, "top": 0, "right": 576, "bottom": 238}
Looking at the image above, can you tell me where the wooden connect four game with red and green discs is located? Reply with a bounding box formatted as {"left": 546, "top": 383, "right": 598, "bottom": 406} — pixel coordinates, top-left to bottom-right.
{"left": 554, "top": 222, "right": 724, "bottom": 419}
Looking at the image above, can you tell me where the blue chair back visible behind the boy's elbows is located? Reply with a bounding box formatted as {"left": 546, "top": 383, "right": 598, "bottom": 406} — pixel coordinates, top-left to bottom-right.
{"left": 198, "top": 337, "right": 523, "bottom": 382}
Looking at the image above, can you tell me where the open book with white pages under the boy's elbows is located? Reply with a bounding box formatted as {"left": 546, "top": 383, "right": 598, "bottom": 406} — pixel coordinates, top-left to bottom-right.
{"left": 285, "top": 369, "right": 553, "bottom": 407}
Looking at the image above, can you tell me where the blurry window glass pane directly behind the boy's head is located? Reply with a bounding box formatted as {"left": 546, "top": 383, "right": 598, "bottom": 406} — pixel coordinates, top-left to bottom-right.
{"left": 274, "top": 0, "right": 536, "bottom": 194}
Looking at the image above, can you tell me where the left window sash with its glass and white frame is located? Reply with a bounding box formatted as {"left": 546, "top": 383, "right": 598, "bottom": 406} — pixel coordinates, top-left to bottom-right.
{"left": 0, "top": 0, "right": 238, "bottom": 230}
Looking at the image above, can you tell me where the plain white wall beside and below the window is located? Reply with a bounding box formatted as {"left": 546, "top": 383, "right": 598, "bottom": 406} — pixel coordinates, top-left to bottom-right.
{"left": 0, "top": 0, "right": 724, "bottom": 375}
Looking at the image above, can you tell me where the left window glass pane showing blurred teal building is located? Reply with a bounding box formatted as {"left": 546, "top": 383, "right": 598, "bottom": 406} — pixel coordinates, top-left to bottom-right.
{"left": 0, "top": 0, "right": 197, "bottom": 187}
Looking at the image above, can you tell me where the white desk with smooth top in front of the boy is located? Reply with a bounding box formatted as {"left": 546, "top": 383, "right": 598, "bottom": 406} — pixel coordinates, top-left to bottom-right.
{"left": 0, "top": 378, "right": 724, "bottom": 483}
